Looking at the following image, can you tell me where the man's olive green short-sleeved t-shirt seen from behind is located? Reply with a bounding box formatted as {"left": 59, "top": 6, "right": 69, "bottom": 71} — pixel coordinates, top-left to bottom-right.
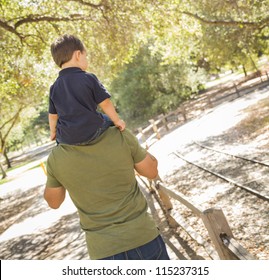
{"left": 46, "top": 127, "right": 159, "bottom": 259}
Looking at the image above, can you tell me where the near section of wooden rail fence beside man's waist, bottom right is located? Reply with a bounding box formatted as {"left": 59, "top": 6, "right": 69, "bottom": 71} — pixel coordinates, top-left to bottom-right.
{"left": 138, "top": 176, "right": 256, "bottom": 260}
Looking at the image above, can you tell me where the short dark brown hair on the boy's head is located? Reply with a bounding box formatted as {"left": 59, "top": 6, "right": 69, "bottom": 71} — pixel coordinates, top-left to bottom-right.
{"left": 50, "top": 34, "right": 85, "bottom": 67}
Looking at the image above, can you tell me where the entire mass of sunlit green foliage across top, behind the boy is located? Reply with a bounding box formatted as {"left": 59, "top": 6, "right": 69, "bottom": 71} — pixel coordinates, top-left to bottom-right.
{"left": 0, "top": 0, "right": 269, "bottom": 160}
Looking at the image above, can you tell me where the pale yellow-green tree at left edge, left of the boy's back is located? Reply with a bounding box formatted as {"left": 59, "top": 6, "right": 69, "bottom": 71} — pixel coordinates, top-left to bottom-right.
{"left": 0, "top": 43, "right": 49, "bottom": 176}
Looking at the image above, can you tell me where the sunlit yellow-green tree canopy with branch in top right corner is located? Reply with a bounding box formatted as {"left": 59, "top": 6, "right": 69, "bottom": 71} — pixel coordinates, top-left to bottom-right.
{"left": 144, "top": 0, "right": 269, "bottom": 72}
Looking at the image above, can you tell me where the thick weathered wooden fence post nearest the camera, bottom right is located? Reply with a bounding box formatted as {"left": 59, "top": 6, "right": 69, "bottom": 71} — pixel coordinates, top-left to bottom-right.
{"left": 201, "top": 209, "right": 237, "bottom": 260}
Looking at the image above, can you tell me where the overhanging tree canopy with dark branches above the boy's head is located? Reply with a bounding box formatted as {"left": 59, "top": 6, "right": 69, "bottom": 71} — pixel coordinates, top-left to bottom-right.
{"left": 0, "top": 0, "right": 154, "bottom": 72}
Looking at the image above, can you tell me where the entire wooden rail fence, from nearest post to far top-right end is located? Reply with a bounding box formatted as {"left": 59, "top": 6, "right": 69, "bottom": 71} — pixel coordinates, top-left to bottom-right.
{"left": 136, "top": 72, "right": 269, "bottom": 260}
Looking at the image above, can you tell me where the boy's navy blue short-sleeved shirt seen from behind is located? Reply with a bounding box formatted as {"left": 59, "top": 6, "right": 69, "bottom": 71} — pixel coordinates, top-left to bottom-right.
{"left": 49, "top": 67, "right": 110, "bottom": 144}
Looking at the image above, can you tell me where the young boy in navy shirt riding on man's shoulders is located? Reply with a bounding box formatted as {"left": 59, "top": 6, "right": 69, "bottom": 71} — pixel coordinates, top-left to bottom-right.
{"left": 49, "top": 35, "right": 125, "bottom": 145}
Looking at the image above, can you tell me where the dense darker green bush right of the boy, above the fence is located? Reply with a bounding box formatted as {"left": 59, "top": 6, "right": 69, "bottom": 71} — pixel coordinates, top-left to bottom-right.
{"left": 111, "top": 45, "right": 205, "bottom": 126}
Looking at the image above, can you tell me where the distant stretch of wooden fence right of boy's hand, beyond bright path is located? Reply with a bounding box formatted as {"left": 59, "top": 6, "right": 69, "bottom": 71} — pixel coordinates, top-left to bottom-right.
{"left": 136, "top": 72, "right": 269, "bottom": 148}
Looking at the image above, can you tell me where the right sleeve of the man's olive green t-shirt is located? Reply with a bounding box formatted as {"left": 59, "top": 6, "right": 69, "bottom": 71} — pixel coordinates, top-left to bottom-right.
{"left": 122, "top": 129, "right": 147, "bottom": 163}
